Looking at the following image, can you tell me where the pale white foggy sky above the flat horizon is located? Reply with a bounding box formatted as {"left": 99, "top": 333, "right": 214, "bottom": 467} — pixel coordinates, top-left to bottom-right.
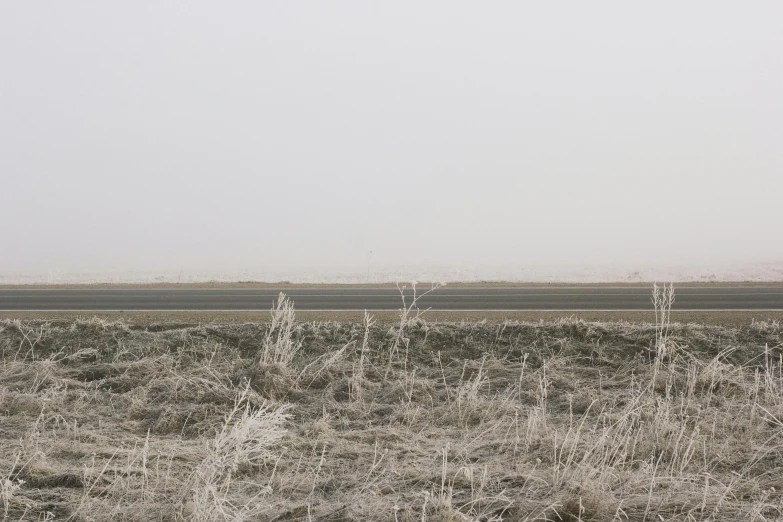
{"left": 0, "top": 1, "right": 783, "bottom": 273}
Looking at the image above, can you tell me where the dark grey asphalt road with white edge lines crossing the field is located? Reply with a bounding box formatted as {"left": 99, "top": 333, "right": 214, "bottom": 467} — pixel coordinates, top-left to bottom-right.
{"left": 0, "top": 286, "right": 783, "bottom": 311}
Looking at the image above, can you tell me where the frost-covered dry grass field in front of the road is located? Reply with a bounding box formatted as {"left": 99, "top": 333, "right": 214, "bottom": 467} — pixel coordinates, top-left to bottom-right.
{"left": 0, "top": 290, "right": 783, "bottom": 522}
